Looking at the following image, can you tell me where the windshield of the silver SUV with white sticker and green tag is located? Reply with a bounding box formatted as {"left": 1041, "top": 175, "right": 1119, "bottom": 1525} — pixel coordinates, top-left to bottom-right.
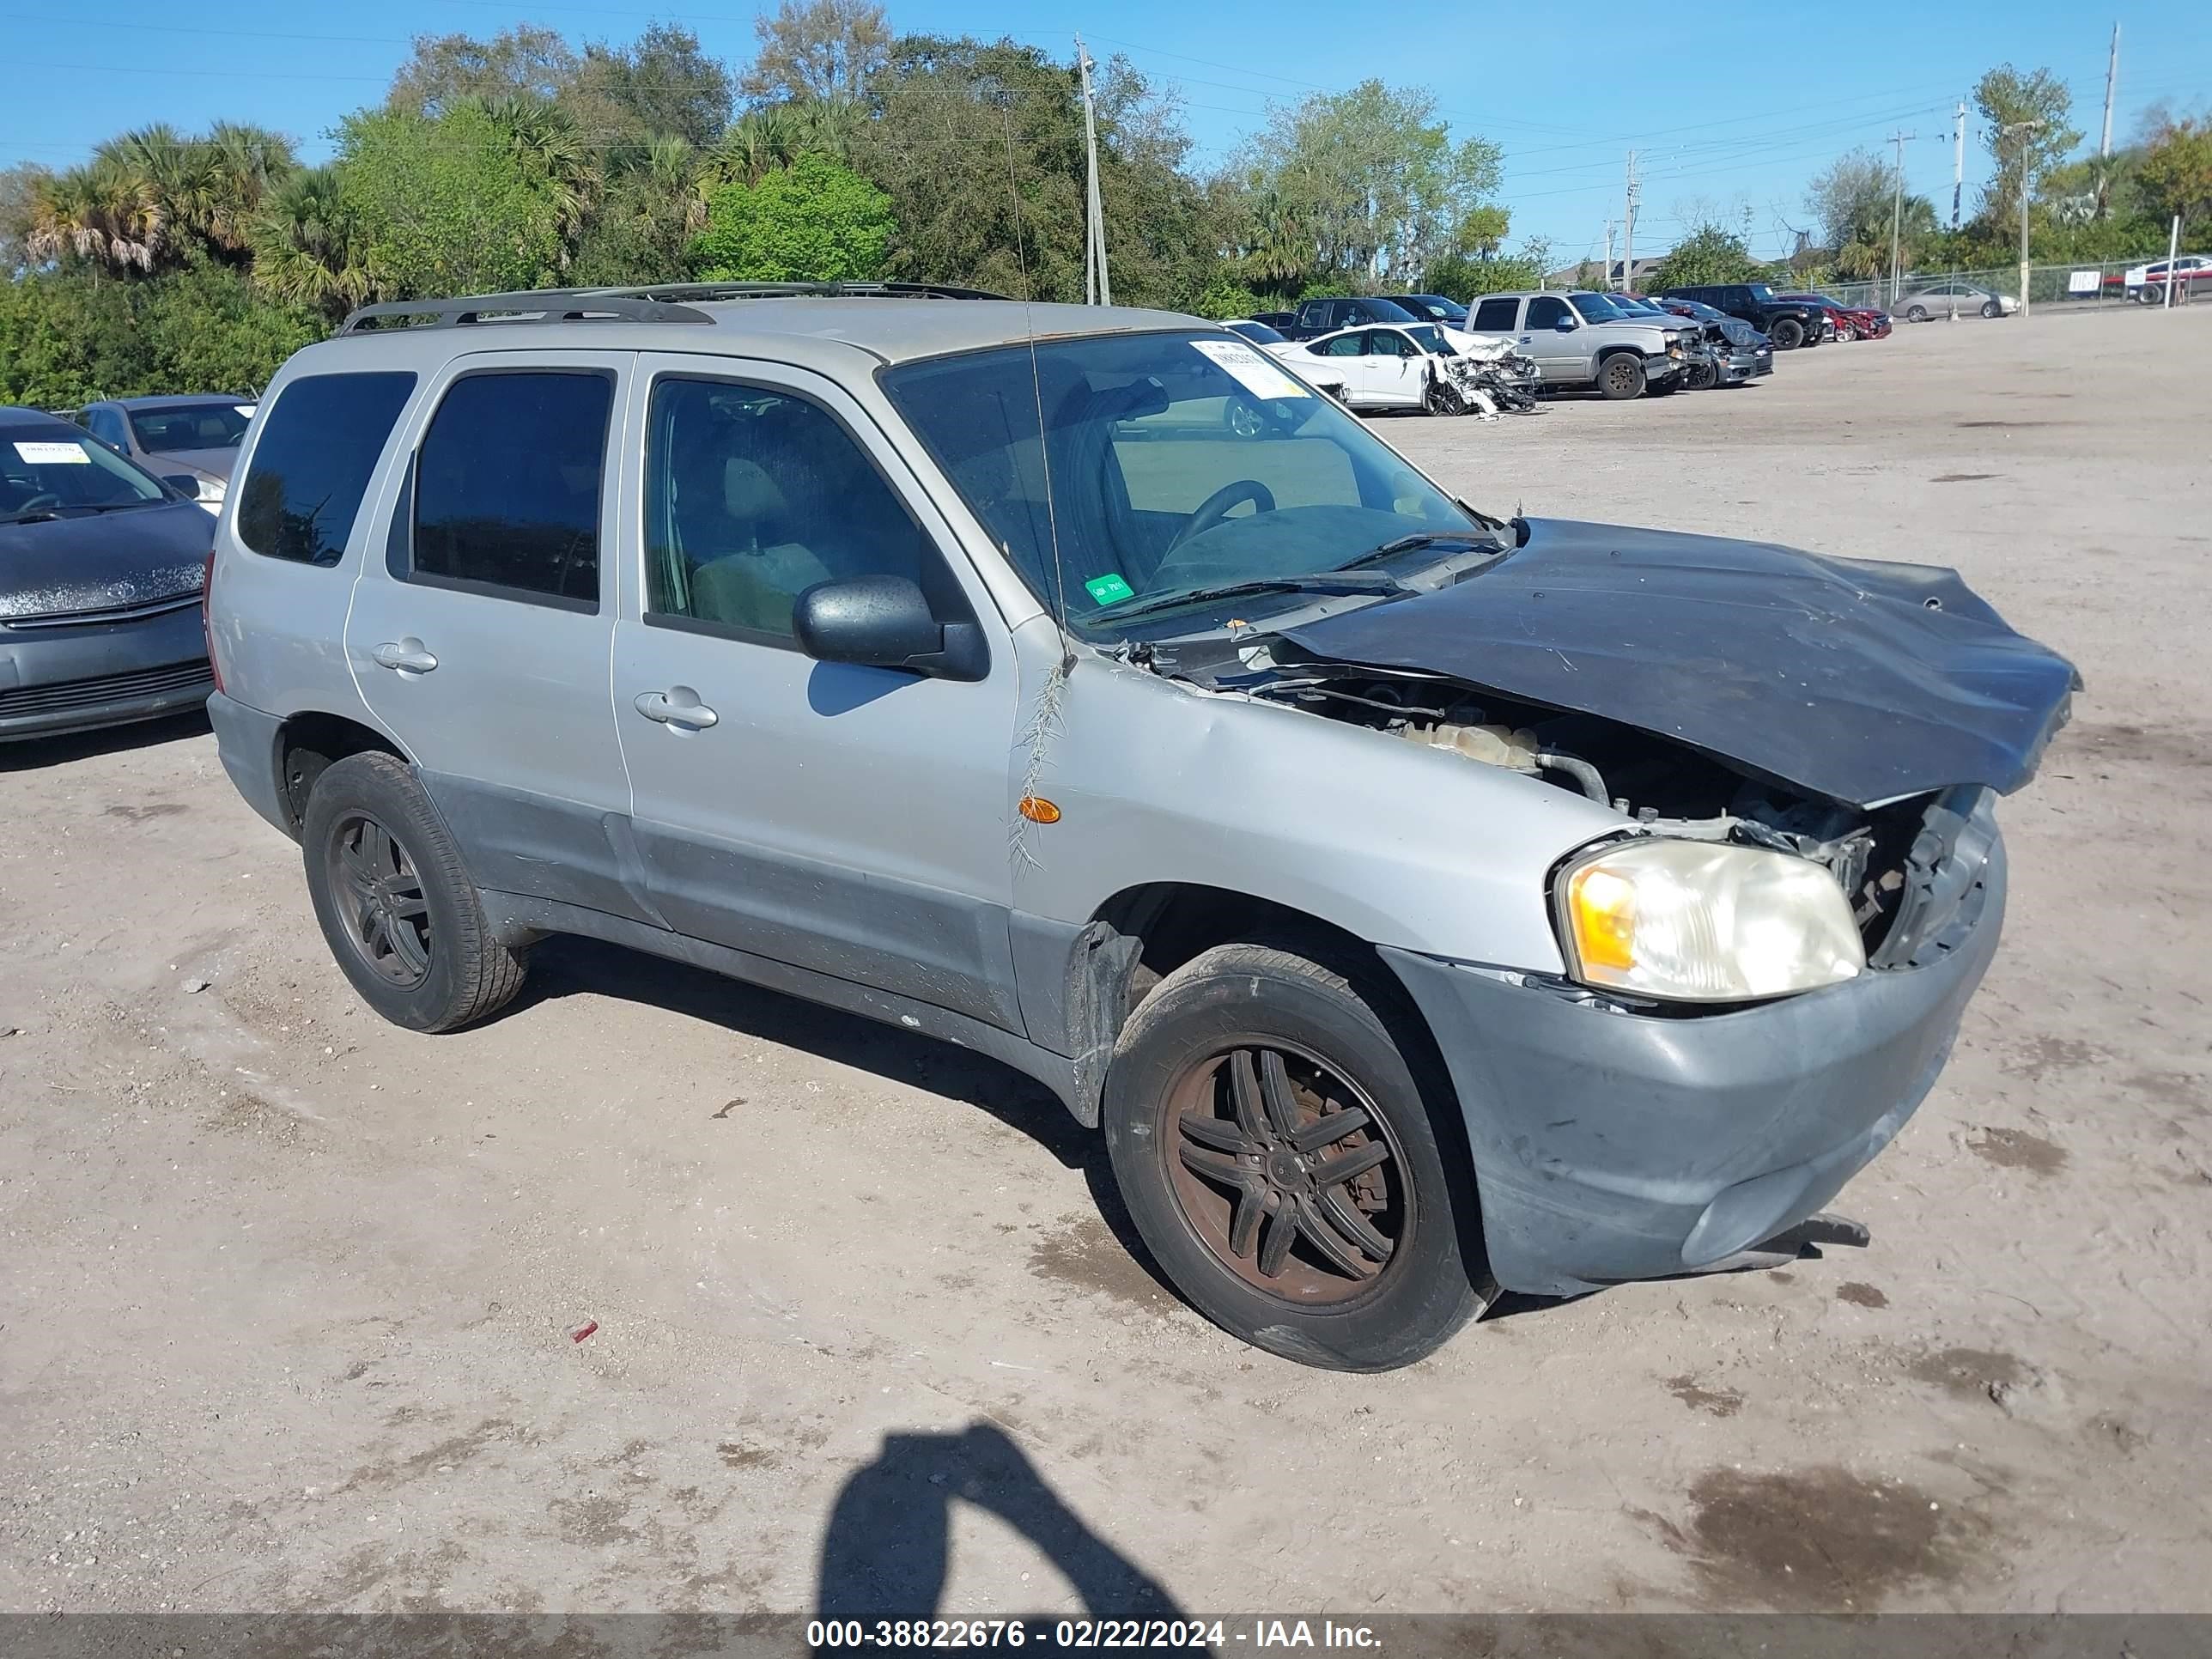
{"left": 880, "top": 334, "right": 1489, "bottom": 637}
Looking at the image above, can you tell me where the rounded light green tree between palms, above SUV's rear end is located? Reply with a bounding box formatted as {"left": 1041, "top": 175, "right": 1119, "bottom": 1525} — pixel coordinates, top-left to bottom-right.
{"left": 337, "top": 100, "right": 562, "bottom": 299}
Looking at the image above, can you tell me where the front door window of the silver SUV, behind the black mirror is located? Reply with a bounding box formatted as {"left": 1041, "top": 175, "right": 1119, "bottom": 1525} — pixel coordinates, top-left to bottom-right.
{"left": 646, "top": 378, "right": 949, "bottom": 644}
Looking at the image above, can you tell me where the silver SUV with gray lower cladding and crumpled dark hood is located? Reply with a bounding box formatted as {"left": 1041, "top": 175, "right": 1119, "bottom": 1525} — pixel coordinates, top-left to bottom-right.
{"left": 208, "top": 288, "right": 2073, "bottom": 1370}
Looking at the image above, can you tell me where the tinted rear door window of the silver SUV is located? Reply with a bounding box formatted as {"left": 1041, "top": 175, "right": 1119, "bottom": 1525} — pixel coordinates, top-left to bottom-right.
{"left": 410, "top": 369, "right": 615, "bottom": 608}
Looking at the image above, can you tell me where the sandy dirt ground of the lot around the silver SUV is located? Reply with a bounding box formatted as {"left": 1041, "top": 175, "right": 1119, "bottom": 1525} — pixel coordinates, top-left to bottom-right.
{"left": 0, "top": 307, "right": 2212, "bottom": 1614}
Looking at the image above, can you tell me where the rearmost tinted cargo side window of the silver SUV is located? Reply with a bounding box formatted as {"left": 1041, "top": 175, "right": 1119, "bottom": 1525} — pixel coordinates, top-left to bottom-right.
{"left": 239, "top": 372, "right": 414, "bottom": 564}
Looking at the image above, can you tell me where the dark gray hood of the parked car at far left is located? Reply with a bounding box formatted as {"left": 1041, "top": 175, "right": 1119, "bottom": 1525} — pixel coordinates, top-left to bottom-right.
{"left": 0, "top": 502, "right": 215, "bottom": 622}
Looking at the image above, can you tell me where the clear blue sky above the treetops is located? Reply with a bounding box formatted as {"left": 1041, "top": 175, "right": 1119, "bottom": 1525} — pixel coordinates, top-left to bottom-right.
{"left": 0, "top": 0, "right": 2212, "bottom": 261}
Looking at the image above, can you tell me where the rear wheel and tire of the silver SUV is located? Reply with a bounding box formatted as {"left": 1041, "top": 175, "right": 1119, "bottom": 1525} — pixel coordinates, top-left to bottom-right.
{"left": 301, "top": 752, "right": 525, "bottom": 1030}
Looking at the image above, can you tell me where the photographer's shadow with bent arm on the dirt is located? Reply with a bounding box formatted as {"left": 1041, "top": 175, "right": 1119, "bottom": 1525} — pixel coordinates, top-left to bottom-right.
{"left": 817, "top": 1422, "right": 1183, "bottom": 1624}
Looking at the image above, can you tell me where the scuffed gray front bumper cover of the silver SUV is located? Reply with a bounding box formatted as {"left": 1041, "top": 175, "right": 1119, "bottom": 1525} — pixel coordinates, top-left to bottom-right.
{"left": 1382, "top": 841, "right": 2004, "bottom": 1297}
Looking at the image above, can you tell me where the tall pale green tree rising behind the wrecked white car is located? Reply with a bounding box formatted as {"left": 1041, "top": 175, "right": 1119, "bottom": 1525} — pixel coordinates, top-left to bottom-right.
{"left": 1234, "top": 80, "right": 1504, "bottom": 285}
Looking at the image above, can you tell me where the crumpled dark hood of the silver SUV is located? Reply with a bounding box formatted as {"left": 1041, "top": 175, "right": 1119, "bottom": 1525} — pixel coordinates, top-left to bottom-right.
{"left": 1283, "top": 520, "right": 2079, "bottom": 807}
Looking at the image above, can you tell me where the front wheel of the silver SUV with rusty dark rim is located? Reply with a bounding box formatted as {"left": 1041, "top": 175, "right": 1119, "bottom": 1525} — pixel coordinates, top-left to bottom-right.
{"left": 1103, "top": 945, "right": 1489, "bottom": 1371}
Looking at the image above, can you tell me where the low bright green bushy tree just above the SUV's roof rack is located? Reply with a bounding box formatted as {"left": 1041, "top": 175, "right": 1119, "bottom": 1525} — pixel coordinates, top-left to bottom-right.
{"left": 696, "top": 155, "right": 896, "bottom": 283}
